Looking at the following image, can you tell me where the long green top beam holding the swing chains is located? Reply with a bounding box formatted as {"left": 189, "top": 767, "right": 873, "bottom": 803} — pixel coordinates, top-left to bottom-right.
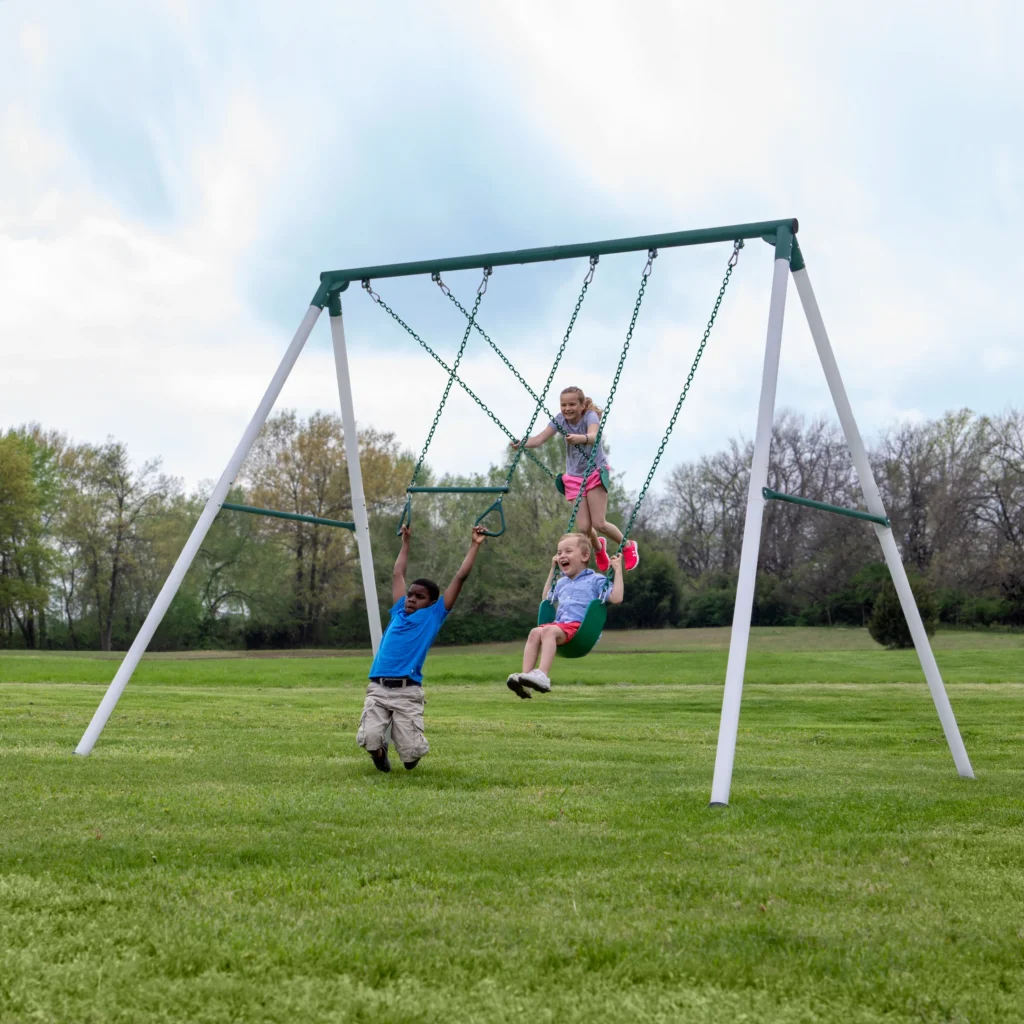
{"left": 317, "top": 217, "right": 798, "bottom": 290}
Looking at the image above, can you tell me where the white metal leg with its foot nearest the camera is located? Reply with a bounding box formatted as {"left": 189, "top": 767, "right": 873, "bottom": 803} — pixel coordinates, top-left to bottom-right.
{"left": 711, "top": 259, "right": 790, "bottom": 806}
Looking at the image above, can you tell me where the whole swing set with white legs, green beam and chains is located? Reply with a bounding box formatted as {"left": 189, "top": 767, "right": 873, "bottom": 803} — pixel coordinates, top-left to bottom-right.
{"left": 75, "top": 219, "right": 974, "bottom": 806}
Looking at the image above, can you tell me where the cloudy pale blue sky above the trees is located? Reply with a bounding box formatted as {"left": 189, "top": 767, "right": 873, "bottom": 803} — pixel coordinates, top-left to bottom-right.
{"left": 0, "top": 0, "right": 1024, "bottom": 497}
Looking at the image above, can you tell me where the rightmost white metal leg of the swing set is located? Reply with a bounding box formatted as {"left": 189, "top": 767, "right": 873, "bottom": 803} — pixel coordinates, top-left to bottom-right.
{"left": 793, "top": 267, "right": 974, "bottom": 778}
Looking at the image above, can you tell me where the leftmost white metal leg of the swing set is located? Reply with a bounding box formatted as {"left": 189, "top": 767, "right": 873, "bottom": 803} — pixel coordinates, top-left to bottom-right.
{"left": 75, "top": 306, "right": 321, "bottom": 755}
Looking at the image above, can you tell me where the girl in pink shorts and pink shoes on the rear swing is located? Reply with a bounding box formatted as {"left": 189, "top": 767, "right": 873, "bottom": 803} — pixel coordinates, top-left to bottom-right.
{"left": 510, "top": 387, "right": 640, "bottom": 572}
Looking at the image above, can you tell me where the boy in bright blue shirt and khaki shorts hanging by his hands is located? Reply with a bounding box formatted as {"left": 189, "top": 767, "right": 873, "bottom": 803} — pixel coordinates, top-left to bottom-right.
{"left": 355, "top": 526, "right": 486, "bottom": 771}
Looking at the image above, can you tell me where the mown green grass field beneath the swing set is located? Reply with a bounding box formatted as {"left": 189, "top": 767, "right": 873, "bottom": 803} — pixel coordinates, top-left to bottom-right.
{"left": 0, "top": 630, "right": 1024, "bottom": 1024}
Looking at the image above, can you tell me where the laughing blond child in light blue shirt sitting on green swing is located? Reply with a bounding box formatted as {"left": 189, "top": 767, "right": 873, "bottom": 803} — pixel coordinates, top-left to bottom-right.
{"left": 508, "top": 534, "right": 623, "bottom": 700}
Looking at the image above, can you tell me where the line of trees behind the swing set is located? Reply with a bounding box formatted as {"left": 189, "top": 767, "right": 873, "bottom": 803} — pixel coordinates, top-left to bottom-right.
{"left": 0, "top": 411, "right": 1024, "bottom": 650}
